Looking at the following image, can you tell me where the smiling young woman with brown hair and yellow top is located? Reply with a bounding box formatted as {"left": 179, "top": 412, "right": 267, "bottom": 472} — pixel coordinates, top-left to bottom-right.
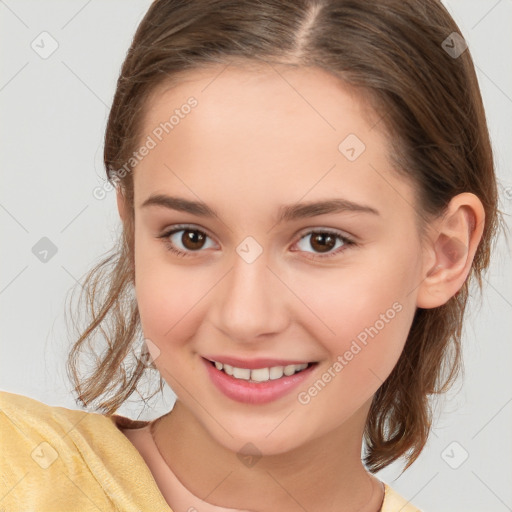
{"left": 0, "top": 0, "right": 497, "bottom": 512}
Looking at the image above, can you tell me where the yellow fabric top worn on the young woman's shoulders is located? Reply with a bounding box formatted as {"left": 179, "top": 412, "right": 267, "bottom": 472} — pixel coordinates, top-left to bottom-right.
{"left": 0, "top": 391, "right": 420, "bottom": 512}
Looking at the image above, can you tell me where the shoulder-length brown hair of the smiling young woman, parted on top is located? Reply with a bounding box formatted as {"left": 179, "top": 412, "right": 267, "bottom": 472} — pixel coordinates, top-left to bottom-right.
{"left": 68, "top": 0, "right": 499, "bottom": 472}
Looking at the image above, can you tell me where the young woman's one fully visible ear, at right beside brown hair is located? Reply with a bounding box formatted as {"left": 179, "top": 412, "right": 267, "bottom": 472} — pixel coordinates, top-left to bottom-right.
{"left": 416, "top": 192, "right": 485, "bottom": 309}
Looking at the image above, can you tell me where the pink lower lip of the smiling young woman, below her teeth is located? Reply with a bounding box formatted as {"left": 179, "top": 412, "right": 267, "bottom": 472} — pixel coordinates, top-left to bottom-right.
{"left": 203, "top": 358, "right": 316, "bottom": 404}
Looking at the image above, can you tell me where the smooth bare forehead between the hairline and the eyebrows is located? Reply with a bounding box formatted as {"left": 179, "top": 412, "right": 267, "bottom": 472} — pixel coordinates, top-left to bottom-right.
{"left": 134, "top": 65, "right": 416, "bottom": 222}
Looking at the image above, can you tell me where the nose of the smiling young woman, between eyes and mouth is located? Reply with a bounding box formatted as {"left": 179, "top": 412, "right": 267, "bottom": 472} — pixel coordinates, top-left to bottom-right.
{"left": 212, "top": 244, "right": 293, "bottom": 343}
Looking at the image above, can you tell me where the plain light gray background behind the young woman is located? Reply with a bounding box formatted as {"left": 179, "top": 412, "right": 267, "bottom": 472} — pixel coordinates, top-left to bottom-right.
{"left": 0, "top": 0, "right": 512, "bottom": 512}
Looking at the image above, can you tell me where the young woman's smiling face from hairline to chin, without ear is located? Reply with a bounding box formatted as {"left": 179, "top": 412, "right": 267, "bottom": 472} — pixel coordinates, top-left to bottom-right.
{"left": 130, "top": 66, "right": 423, "bottom": 454}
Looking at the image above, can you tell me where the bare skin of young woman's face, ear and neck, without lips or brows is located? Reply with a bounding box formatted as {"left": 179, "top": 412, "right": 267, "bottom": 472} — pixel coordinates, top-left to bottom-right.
{"left": 118, "top": 65, "right": 484, "bottom": 512}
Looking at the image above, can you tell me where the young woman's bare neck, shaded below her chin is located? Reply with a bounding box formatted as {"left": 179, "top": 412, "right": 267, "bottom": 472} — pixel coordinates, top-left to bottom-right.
{"left": 153, "top": 400, "right": 384, "bottom": 512}
